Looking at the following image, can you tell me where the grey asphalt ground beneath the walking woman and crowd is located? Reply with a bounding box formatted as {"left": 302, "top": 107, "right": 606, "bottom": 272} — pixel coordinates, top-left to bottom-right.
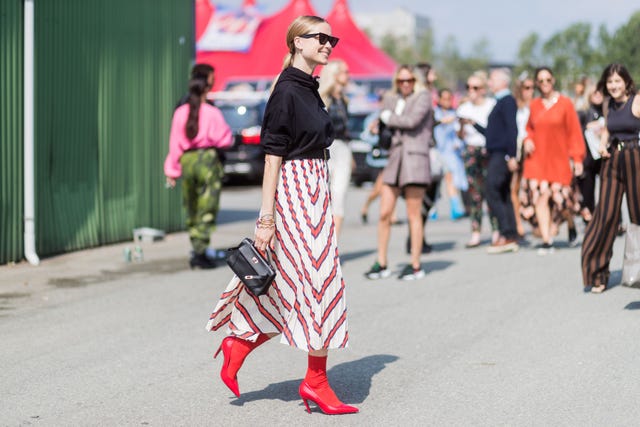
{"left": 0, "top": 187, "right": 640, "bottom": 426}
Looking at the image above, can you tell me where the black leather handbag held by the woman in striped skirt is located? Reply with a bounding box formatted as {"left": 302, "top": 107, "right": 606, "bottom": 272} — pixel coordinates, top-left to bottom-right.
{"left": 227, "top": 237, "right": 276, "bottom": 296}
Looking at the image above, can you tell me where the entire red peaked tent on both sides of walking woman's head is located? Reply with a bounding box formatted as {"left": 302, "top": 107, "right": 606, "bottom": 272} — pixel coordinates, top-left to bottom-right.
{"left": 196, "top": 0, "right": 396, "bottom": 91}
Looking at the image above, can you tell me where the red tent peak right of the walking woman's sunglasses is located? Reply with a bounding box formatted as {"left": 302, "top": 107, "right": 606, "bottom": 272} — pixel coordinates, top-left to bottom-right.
{"left": 326, "top": 0, "right": 396, "bottom": 78}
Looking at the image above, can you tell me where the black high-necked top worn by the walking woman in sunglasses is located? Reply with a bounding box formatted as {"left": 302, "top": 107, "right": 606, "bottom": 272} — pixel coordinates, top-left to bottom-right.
{"left": 260, "top": 67, "right": 333, "bottom": 160}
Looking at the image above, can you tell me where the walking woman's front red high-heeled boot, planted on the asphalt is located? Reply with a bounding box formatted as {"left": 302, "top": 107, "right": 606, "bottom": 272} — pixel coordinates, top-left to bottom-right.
{"left": 298, "top": 355, "right": 358, "bottom": 415}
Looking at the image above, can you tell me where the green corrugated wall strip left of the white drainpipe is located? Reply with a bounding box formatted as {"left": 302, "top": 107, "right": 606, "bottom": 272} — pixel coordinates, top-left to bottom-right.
{"left": 0, "top": 0, "right": 24, "bottom": 264}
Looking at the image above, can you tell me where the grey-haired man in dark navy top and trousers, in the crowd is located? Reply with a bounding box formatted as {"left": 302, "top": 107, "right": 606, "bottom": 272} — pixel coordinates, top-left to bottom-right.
{"left": 485, "top": 68, "right": 519, "bottom": 254}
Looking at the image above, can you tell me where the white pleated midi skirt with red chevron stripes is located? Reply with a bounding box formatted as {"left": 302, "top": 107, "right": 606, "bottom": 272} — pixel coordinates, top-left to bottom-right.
{"left": 207, "top": 159, "right": 349, "bottom": 351}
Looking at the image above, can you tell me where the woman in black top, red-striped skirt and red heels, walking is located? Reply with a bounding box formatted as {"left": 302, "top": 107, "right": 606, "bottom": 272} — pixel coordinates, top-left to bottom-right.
{"left": 207, "top": 16, "right": 358, "bottom": 414}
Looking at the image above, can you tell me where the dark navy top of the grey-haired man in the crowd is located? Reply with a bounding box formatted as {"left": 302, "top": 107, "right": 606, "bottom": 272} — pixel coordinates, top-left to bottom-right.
{"left": 485, "top": 95, "right": 518, "bottom": 157}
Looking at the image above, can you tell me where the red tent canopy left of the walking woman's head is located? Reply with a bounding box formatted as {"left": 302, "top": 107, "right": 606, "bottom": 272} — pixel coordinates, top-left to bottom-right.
{"left": 196, "top": 0, "right": 317, "bottom": 90}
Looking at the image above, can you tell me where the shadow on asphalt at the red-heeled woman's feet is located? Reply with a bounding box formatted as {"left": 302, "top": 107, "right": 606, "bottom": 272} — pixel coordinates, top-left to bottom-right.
{"left": 231, "top": 354, "right": 398, "bottom": 406}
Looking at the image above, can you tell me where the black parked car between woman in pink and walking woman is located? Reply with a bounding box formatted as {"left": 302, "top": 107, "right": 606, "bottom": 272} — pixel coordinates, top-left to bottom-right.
{"left": 213, "top": 93, "right": 267, "bottom": 183}
